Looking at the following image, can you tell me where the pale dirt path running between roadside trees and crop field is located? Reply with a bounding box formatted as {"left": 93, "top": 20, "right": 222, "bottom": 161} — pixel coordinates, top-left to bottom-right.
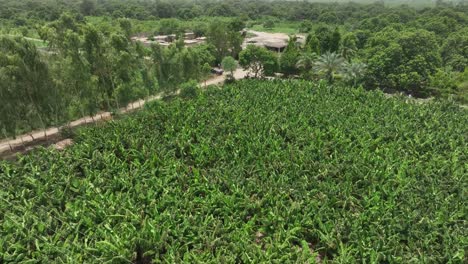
{"left": 0, "top": 69, "right": 247, "bottom": 159}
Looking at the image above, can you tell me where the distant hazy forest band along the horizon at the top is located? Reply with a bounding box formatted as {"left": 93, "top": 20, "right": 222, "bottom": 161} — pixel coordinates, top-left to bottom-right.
{"left": 0, "top": 0, "right": 468, "bottom": 24}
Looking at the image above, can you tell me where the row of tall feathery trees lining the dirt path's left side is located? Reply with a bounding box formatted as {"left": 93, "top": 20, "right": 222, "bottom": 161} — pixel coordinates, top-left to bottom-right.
{"left": 0, "top": 13, "right": 242, "bottom": 137}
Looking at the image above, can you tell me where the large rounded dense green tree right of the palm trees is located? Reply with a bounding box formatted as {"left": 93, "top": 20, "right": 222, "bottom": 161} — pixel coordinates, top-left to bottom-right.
{"left": 366, "top": 28, "right": 441, "bottom": 96}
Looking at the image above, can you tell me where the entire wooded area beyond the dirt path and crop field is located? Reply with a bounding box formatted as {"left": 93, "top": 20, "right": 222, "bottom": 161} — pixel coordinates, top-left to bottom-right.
{"left": 0, "top": 0, "right": 468, "bottom": 136}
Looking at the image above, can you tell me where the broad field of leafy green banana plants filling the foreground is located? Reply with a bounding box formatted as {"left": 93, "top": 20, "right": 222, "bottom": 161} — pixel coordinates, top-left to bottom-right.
{"left": 0, "top": 80, "right": 468, "bottom": 263}
